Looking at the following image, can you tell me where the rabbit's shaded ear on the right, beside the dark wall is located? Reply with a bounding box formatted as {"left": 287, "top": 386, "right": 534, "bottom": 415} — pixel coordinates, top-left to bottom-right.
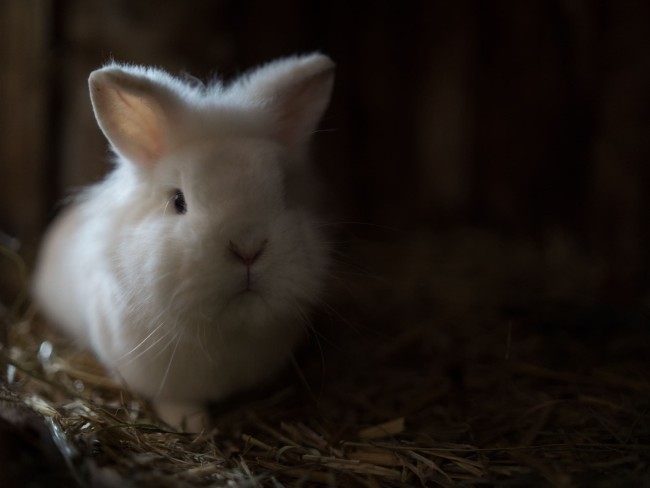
{"left": 236, "top": 54, "right": 335, "bottom": 146}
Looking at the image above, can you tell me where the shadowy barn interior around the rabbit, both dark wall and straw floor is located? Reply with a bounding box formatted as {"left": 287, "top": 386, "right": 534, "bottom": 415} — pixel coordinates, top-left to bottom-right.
{"left": 0, "top": 0, "right": 650, "bottom": 487}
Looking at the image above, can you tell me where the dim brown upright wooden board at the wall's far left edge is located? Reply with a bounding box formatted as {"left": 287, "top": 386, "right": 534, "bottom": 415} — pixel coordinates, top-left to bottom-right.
{"left": 0, "top": 0, "right": 53, "bottom": 304}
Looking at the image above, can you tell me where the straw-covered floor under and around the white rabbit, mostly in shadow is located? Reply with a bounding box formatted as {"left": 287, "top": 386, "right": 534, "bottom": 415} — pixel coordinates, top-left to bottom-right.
{"left": 0, "top": 231, "right": 650, "bottom": 487}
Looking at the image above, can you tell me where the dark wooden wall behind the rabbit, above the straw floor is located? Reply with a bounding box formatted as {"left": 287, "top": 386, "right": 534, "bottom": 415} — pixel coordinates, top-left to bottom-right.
{"left": 0, "top": 0, "right": 650, "bottom": 305}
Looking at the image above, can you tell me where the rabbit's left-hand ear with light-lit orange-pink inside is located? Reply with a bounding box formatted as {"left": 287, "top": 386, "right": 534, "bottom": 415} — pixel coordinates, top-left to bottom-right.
{"left": 88, "top": 66, "right": 177, "bottom": 166}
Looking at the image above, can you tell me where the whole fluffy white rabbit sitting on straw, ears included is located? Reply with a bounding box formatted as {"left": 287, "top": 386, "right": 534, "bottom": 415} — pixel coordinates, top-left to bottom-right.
{"left": 33, "top": 54, "right": 334, "bottom": 427}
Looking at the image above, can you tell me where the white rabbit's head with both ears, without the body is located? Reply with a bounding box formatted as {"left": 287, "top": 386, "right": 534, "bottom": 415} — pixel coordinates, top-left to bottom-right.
{"left": 90, "top": 54, "right": 334, "bottom": 334}
